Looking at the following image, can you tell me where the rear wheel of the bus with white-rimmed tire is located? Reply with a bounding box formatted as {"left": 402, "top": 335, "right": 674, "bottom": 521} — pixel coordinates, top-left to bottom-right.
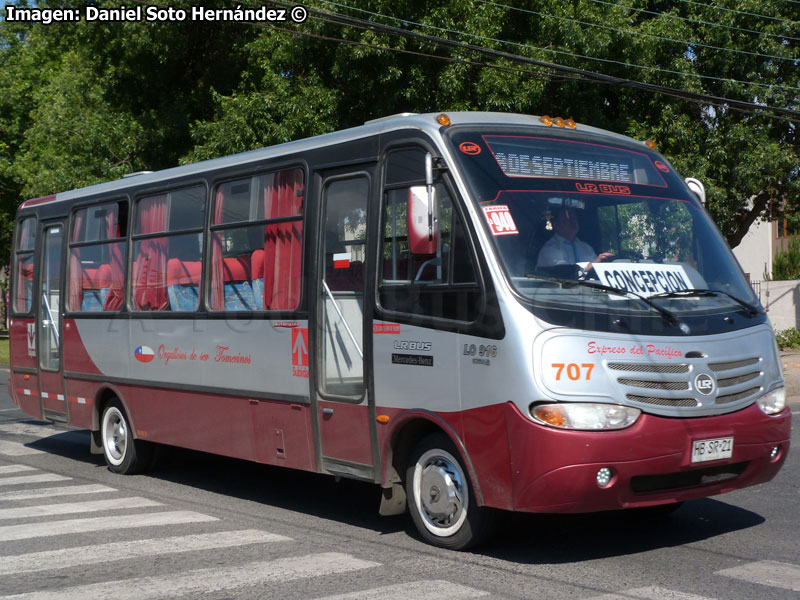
{"left": 100, "top": 398, "right": 154, "bottom": 475}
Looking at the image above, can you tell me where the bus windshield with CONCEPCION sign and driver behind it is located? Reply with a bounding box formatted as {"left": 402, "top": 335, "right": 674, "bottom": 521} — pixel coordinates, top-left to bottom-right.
{"left": 450, "top": 128, "right": 758, "bottom": 322}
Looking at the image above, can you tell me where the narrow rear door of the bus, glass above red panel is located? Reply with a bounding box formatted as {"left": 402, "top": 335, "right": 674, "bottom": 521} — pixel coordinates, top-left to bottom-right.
{"left": 36, "top": 221, "right": 67, "bottom": 421}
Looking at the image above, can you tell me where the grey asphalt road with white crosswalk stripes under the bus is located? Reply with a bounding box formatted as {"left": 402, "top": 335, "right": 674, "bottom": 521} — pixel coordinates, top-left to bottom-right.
{"left": 0, "top": 354, "right": 800, "bottom": 600}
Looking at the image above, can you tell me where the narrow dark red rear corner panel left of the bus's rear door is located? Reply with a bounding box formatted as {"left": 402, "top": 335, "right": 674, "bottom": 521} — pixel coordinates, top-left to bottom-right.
{"left": 8, "top": 318, "right": 43, "bottom": 419}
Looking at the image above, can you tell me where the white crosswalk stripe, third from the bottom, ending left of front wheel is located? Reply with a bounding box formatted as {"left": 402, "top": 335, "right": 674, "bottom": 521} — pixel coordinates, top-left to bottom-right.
{"left": 0, "top": 529, "right": 292, "bottom": 575}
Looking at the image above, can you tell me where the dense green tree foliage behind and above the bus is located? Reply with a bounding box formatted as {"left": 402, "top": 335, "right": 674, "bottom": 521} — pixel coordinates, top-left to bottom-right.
{"left": 0, "top": 0, "right": 800, "bottom": 268}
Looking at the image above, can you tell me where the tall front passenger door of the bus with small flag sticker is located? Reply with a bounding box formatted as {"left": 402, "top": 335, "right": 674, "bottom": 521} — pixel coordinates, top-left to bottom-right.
{"left": 311, "top": 171, "right": 377, "bottom": 480}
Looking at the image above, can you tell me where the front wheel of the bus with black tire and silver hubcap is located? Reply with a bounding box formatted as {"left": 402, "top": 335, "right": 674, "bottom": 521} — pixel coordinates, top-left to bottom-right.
{"left": 405, "top": 433, "right": 495, "bottom": 550}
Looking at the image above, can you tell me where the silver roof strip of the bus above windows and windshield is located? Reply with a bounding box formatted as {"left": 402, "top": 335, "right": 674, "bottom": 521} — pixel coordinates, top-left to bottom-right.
{"left": 19, "top": 112, "right": 642, "bottom": 210}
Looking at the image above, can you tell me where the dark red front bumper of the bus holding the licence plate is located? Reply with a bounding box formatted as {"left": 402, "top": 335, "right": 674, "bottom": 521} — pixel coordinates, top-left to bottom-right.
{"left": 506, "top": 404, "right": 791, "bottom": 512}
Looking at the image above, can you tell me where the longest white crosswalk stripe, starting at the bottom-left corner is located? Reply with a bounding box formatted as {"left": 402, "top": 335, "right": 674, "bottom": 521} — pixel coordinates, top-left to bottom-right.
{"left": 0, "top": 552, "right": 380, "bottom": 600}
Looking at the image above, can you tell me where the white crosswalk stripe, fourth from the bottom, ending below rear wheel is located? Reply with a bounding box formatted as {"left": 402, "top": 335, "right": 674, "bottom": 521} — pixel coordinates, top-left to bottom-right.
{"left": 0, "top": 511, "right": 219, "bottom": 542}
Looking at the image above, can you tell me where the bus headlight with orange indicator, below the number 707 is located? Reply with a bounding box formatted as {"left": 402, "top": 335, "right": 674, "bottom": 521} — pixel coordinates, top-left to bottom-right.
{"left": 530, "top": 402, "right": 642, "bottom": 431}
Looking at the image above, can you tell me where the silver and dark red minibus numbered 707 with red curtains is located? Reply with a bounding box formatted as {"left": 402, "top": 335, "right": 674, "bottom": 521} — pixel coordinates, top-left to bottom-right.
{"left": 9, "top": 112, "right": 791, "bottom": 549}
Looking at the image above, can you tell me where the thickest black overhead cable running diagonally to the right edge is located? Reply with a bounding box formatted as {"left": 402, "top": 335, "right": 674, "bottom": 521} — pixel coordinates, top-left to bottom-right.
{"left": 288, "top": 0, "right": 800, "bottom": 120}
